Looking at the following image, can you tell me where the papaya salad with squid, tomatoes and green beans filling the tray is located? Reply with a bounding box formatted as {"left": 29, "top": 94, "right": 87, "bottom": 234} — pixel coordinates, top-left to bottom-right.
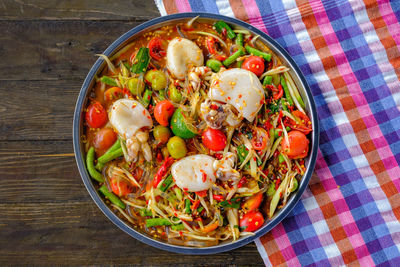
{"left": 82, "top": 18, "right": 312, "bottom": 247}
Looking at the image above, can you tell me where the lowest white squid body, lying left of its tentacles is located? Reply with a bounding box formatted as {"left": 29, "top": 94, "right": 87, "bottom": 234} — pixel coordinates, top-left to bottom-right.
{"left": 171, "top": 154, "right": 216, "bottom": 192}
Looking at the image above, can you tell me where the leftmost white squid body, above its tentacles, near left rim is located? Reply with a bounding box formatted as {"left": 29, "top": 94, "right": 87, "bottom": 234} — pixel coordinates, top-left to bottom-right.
{"left": 109, "top": 99, "right": 153, "bottom": 140}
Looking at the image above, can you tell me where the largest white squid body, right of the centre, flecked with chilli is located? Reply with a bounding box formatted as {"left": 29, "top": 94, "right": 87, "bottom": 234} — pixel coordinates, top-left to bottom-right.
{"left": 208, "top": 68, "right": 264, "bottom": 122}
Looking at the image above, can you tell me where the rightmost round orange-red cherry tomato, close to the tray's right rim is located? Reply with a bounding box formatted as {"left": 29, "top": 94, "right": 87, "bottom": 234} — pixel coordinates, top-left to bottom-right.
{"left": 282, "top": 130, "right": 310, "bottom": 159}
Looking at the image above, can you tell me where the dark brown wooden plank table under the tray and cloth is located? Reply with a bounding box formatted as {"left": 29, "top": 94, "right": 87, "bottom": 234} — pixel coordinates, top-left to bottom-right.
{"left": 0, "top": 0, "right": 263, "bottom": 266}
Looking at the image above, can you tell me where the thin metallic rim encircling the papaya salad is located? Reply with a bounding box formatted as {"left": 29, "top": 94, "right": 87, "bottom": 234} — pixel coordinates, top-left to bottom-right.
{"left": 73, "top": 12, "right": 319, "bottom": 255}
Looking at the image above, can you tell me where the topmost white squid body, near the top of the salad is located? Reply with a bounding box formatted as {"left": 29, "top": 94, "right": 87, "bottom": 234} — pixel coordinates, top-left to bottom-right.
{"left": 167, "top": 37, "right": 204, "bottom": 80}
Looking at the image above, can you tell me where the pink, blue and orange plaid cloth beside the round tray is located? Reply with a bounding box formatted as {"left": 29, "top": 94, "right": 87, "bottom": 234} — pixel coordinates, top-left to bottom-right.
{"left": 156, "top": 0, "right": 400, "bottom": 266}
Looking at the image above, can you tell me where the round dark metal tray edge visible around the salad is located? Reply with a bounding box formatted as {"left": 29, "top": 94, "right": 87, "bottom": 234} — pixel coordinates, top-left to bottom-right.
{"left": 73, "top": 13, "right": 319, "bottom": 254}
